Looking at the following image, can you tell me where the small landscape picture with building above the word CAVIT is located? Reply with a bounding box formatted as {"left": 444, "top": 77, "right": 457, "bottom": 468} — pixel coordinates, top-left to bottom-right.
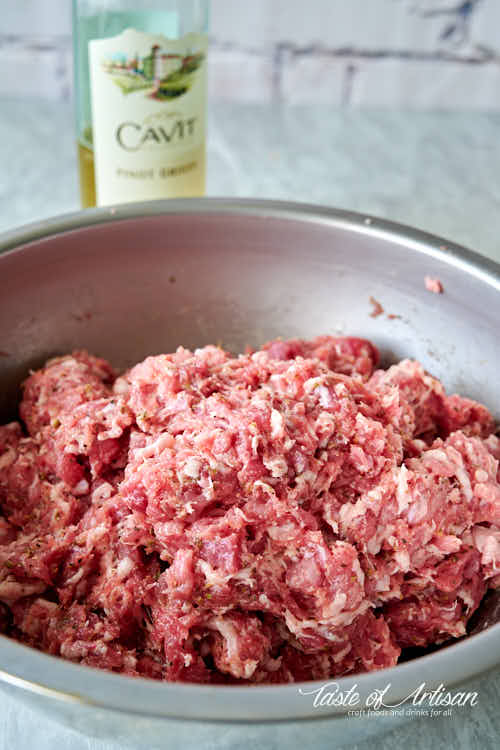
{"left": 101, "top": 44, "right": 205, "bottom": 101}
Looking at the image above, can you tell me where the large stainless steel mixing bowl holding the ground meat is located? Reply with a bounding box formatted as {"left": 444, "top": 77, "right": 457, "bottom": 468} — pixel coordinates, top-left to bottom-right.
{"left": 0, "top": 199, "right": 500, "bottom": 750}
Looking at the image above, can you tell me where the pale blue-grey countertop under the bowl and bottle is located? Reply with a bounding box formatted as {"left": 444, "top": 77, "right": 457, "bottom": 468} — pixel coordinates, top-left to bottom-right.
{"left": 0, "top": 99, "right": 500, "bottom": 750}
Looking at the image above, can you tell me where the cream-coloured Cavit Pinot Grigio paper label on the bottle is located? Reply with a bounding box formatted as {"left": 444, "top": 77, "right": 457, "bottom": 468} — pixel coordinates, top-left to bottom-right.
{"left": 89, "top": 29, "right": 207, "bottom": 206}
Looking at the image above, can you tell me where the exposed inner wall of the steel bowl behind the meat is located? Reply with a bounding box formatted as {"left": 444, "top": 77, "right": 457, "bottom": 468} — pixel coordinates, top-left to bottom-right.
{"left": 0, "top": 201, "right": 500, "bottom": 724}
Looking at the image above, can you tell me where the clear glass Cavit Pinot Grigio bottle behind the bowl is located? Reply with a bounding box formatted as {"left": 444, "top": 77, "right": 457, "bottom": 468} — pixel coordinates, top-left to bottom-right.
{"left": 73, "top": 0, "right": 208, "bottom": 208}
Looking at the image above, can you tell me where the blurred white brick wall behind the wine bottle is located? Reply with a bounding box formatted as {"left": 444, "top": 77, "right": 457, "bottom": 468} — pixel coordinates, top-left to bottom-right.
{"left": 0, "top": 0, "right": 500, "bottom": 110}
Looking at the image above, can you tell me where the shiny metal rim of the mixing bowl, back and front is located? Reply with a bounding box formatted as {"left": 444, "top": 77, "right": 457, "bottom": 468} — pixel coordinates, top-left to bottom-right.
{"left": 0, "top": 198, "right": 500, "bottom": 723}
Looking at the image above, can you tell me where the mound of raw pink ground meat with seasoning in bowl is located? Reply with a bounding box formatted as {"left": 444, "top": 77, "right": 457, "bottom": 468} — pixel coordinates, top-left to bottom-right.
{"left": 0, "top": 336, "right": 500, "bottom": 683}
